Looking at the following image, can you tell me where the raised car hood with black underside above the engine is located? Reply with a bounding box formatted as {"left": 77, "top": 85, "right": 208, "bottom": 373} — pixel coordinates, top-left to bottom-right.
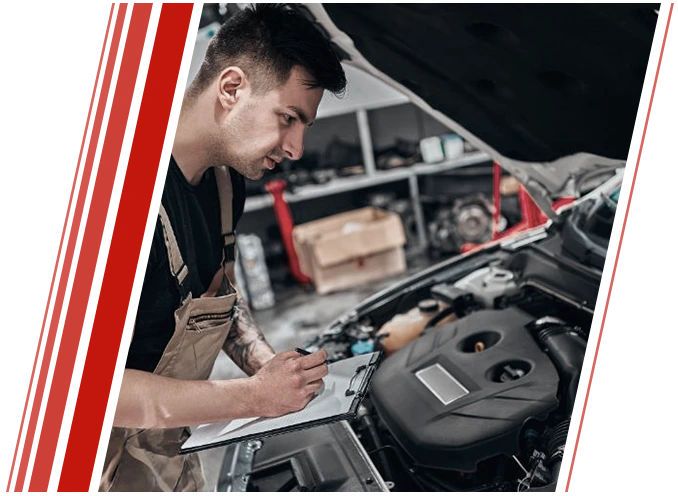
{"left": 303, "top": 1, "right": 661, "bottom": 218}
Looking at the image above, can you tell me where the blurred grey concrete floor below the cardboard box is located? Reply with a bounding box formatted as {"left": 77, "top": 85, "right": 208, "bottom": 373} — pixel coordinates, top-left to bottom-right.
{"left": 200, "top": 256, "right": 430, "bottom": 491}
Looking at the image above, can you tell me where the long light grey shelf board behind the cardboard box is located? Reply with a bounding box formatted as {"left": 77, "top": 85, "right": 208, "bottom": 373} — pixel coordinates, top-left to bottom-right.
{"left": 245, "top": 152, "right": 490, "bottom": 212}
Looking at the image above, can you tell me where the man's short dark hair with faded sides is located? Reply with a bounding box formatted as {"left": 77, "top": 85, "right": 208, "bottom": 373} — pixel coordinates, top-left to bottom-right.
{"left": 187, "top": 3, "right": 346, "bottom": 96}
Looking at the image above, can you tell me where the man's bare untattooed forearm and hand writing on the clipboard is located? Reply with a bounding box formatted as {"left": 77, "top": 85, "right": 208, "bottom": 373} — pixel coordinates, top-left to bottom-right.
{"left": 111, "top": 350, "right": 328, "bottom": 429}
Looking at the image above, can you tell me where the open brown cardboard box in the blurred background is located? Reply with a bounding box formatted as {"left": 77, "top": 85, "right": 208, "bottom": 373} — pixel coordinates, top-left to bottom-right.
{"left": 293, "top": 207, "right": 407, "bottom": 294}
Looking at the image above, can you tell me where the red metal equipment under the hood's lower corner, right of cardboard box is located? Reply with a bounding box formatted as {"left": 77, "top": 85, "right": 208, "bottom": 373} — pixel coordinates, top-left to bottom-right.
{"left": 461, "top": 162, "right": 574, "bottom": 253}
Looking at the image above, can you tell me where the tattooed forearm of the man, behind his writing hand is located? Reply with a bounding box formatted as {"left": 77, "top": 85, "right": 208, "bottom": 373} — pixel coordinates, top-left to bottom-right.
{"left": 224, "top": 295, "right": 274, "bottom": 376}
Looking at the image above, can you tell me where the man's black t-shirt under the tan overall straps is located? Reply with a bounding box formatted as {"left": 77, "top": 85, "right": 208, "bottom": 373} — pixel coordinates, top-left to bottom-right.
{"left": 121, "top": 155, "right": 245, "bottom": 372}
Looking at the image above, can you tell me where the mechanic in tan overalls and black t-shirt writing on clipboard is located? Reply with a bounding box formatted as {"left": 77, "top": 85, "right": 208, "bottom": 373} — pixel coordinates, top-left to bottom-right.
{"left": 97, "top": 4, "right": 346, "bottom": 493}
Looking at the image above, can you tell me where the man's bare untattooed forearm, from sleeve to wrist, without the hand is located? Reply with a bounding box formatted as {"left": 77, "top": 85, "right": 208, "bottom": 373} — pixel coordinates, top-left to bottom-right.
{"left": 111, "top": 369, "right": 261, "bottom": 429}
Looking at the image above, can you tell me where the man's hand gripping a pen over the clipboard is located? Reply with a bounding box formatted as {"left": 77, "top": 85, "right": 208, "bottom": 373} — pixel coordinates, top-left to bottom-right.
{"left": 251, "top": 350, "right": 328, "bottom": 417}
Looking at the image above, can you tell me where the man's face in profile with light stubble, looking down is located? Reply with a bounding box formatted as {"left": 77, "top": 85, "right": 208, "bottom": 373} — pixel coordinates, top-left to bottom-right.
{"left": 214, "top": 67, "right": 323, "bottom": 180}
